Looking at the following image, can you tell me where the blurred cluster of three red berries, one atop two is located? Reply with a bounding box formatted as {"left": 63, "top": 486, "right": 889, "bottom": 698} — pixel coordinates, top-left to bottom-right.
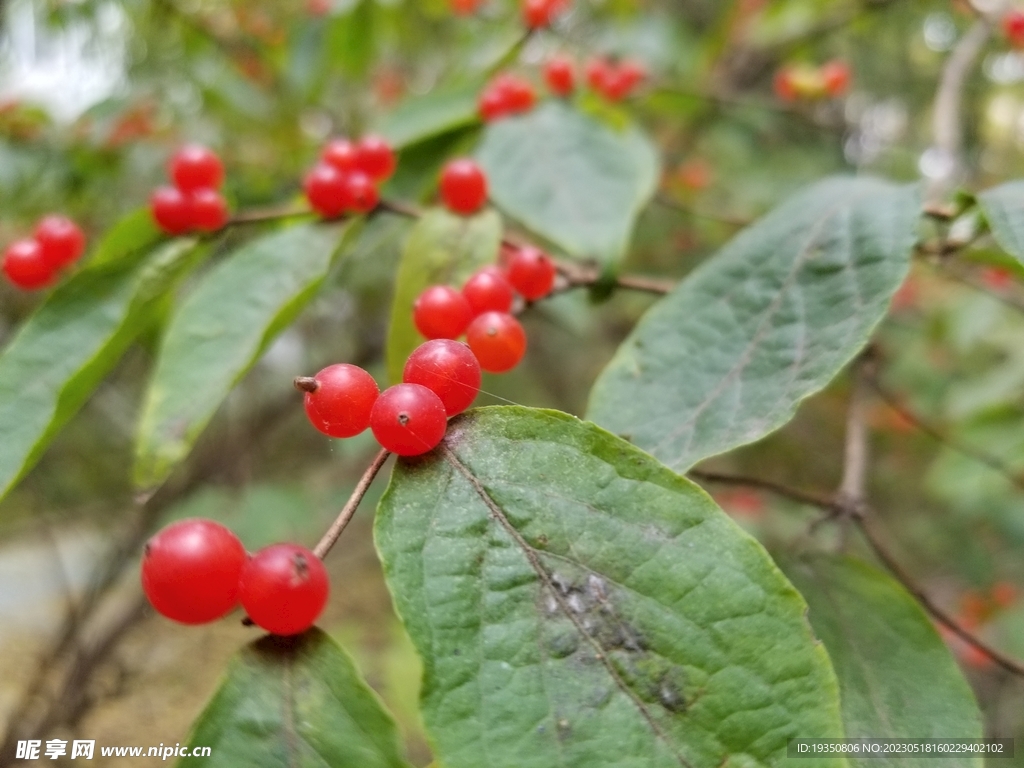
{"left": 150, "top": 144, "right": 227, "bottom": 236}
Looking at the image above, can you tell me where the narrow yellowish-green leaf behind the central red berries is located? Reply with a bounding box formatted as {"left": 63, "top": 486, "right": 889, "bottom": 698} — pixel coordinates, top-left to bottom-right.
{"left": 387, "top": 208, "right": 502, "bottom": 382}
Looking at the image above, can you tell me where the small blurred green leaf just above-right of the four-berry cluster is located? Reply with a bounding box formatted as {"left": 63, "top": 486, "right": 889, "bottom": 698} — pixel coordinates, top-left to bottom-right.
{"left": 378, "top": 80, "right": 480, "bottom": 148}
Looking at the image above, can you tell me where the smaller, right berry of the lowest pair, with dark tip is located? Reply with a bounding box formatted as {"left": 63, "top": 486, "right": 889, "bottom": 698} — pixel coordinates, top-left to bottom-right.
{"left": 239, "top": 544, "right": 331, "bottom": 636}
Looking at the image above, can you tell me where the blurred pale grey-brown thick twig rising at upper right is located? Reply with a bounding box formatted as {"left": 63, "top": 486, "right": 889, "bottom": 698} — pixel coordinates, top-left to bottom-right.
{"left": 928, "top": 17, "right": 992, "bottom": 201}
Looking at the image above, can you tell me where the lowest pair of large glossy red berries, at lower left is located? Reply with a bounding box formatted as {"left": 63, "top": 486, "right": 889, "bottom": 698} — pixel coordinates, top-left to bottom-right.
{"left": 141, "top": 519, "right": 330, "bottom": 635}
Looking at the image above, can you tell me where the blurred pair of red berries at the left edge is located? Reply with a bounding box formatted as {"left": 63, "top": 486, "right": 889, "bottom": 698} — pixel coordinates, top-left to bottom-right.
{"left": 3, "top": 215, "right": 85, "bottom": 291}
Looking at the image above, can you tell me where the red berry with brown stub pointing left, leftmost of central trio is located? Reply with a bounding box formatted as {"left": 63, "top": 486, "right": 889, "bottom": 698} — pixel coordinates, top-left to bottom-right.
{"left": 304, "top": 362, "right": 380, "bottom": 437}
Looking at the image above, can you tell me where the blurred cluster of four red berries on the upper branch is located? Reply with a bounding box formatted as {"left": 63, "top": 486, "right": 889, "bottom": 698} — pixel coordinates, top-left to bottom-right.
{"left": 303, "top": 136, "right": 397, "bottom": 218}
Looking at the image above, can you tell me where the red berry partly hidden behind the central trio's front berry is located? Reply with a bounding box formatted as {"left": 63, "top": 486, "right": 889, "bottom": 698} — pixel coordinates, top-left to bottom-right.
{"left": 401, "top": 339, "right": 480, "bottom": 416}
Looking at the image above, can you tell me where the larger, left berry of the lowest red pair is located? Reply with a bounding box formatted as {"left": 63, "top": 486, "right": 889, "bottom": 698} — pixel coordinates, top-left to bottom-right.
{"left": 142, "top": 519, "right": 248, "bottom": 624}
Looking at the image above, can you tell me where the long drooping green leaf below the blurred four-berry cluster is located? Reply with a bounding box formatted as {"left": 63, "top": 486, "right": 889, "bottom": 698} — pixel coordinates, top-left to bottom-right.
{"left": 135, "top": 224, "right": 352, "bottom": 488}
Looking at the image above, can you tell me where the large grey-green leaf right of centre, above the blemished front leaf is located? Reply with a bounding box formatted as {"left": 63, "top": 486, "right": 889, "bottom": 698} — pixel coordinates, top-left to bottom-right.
{"left": 588, "top": 178, "right": 919, "bottom": 470}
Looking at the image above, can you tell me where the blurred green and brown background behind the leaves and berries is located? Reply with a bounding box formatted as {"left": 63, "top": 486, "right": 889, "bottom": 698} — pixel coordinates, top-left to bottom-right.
{"left": 0, "top": 0, "right": 1024, "bottom": 766}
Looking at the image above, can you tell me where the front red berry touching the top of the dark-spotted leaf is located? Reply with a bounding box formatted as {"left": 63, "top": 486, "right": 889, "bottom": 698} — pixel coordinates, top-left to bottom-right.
{"left": 370, "top": 384, "right": 447, "bottom": 456}
